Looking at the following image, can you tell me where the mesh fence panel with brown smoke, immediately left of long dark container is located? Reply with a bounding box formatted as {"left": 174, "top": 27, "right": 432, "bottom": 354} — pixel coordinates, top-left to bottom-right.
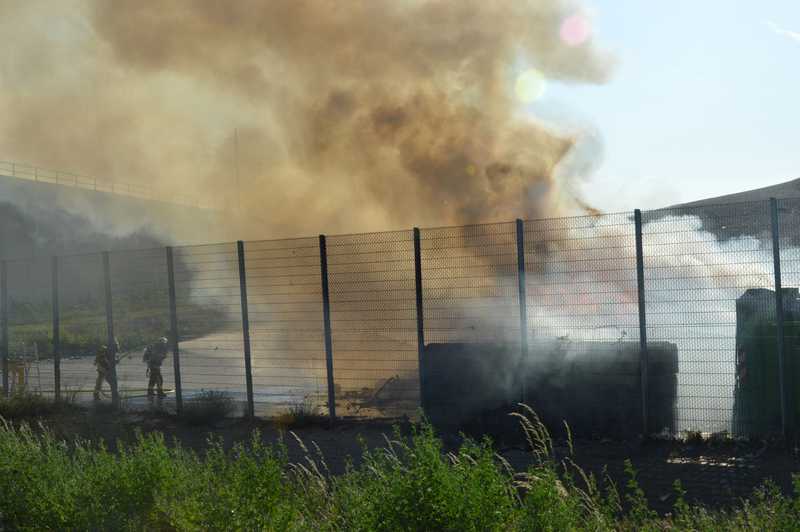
{"left": 327, "top": 231, "right": 419, "bottom": 417}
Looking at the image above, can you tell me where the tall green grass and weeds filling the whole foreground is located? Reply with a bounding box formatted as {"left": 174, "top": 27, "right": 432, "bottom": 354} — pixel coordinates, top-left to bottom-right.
{"left": 0, "top": 411, "right": 800, "bottom": 531}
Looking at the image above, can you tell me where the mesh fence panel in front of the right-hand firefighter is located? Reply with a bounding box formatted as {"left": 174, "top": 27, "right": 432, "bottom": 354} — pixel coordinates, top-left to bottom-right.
{"left": 109, "top": 248, "right": 175, "bottom": 405}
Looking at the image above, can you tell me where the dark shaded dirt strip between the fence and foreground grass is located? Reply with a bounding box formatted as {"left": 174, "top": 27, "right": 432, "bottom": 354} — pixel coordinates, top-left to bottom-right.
{"left": 12, "top": 408, "right": 800, "bottom": 512}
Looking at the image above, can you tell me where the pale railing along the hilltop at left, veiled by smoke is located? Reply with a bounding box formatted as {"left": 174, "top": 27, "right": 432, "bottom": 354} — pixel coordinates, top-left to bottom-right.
{"left": 0, "top": 161, "right": 227, "bottom": 210}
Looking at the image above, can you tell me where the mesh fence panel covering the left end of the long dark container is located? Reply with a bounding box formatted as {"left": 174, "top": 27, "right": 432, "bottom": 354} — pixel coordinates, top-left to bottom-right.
{"left": 420, "top": 223, "right": 521, "bottom": 426}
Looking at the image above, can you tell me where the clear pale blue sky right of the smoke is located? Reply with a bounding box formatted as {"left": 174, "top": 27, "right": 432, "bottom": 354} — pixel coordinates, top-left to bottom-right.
{"left": 528, "top": 0, "right": 800, "bottom": 211}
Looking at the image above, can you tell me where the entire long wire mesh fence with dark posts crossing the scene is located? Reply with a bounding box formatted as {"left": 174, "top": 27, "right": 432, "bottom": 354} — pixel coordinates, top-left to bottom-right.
{"left": 0, "top": 200, "right": 800, "bottom": 436}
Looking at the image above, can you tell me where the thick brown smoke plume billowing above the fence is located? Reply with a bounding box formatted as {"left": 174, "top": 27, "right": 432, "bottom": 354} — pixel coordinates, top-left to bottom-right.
{"left": 0, "top": 0, "right": 608, "bottom": 238}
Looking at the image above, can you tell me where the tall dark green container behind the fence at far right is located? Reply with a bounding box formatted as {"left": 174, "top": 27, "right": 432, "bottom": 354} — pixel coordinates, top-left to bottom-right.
{"left": 732, "top": 288, "right": 800, "bottom": 438}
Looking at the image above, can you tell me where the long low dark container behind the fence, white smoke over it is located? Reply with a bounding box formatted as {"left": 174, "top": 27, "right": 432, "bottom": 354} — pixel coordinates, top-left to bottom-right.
{"left": 422, "top": 339, "right": 678, "bottom": 438}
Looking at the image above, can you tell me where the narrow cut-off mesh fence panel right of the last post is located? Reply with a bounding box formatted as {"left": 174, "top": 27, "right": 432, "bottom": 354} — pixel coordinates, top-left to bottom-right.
{"left": 777, "top": 199, "right": 800, "bottom": 438}
